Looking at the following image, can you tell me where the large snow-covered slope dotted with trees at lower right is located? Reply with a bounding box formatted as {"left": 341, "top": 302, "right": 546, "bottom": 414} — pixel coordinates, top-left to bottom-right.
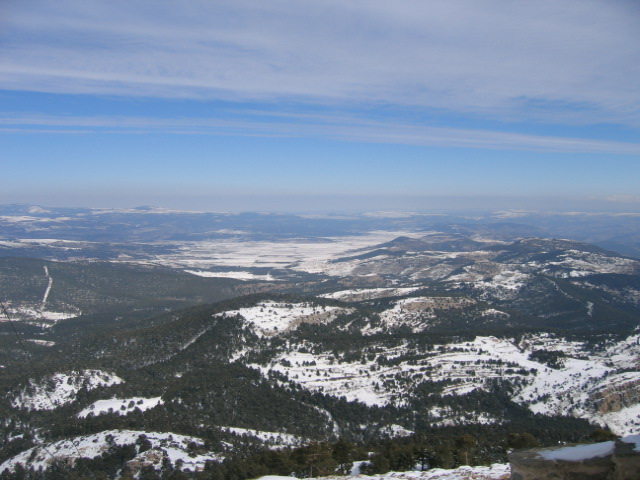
{"left": 245, "top": 334, "right": 640, "bottom": 435}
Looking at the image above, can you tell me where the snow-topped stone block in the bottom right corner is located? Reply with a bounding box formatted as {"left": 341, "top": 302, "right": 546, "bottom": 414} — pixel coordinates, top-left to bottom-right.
{"left": 509, "top": 435, "right": 640, "bottom": 480}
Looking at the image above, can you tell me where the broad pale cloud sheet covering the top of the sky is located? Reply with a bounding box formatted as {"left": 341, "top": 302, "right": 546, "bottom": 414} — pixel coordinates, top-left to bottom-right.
{"left": 0, "top": 0, "right": 640, "bottom": 126}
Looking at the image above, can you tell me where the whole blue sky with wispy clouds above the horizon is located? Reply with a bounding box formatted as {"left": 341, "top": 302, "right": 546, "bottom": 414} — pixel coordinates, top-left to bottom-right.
{"left": 0, "top": 0, "right": 640, "bottom": 211}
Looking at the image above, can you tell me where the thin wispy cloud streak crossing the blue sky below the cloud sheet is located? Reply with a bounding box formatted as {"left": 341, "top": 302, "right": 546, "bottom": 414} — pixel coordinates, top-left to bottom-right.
{"left": 0, "top": 112, "right": 640, "bottom": 155}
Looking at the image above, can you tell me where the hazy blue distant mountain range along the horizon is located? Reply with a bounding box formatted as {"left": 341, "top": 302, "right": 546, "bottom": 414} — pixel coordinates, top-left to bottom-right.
{"left": 0, "top": 205, "right": 640, "bottom": 258}
